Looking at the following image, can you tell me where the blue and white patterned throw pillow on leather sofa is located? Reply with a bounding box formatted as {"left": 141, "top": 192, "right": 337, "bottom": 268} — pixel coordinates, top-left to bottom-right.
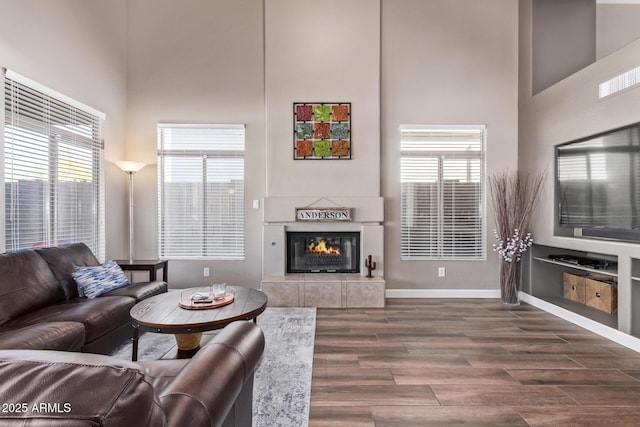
{"left": 71, "top": 261, "right": 131, "bottom": 299}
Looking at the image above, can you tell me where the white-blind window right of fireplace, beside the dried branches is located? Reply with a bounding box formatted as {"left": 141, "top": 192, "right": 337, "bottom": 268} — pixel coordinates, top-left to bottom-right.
{"left": 400, "top": 125, "right": 486, "bottom": 260}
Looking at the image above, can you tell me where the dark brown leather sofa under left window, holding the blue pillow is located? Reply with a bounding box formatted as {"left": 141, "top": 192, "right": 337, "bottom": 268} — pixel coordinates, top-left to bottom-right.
{"left": 0, "top": 243, "right": 167, "bottom": 353}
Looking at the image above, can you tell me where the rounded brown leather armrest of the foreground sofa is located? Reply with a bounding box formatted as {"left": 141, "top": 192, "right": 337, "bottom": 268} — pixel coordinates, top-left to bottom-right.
{"left": 155, "top": 321, "right": 265, "bottom": 426}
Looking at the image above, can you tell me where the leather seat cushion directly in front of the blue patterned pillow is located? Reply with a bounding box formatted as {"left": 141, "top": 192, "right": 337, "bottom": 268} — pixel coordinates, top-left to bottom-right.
{"left": 7, "top": 297, "right": 136, "bottom": 343}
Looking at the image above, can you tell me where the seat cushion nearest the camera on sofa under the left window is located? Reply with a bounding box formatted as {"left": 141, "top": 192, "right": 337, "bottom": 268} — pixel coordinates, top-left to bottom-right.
{"left": 0, "top": 322, "right": 84, "bottom": 351}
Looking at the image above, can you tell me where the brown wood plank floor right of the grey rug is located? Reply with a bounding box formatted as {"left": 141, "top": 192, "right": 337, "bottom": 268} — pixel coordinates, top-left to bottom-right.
{"left": 309, "top": 299, "right": 640, "bottom": 427}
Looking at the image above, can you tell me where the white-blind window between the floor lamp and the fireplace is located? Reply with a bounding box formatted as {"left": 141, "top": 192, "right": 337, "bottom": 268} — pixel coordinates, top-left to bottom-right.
{"left": 158, "top": 123, "right": 245, "bottom": 260}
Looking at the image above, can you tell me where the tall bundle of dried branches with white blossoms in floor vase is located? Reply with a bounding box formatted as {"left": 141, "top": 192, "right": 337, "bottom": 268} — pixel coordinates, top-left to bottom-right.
{"left": 489, "top": 171, "right": 545, "bottom": 306}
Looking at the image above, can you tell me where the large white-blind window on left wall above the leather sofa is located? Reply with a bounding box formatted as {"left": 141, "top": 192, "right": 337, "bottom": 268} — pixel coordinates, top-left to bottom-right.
{"left": 4, "top": 70, "right": 105, "bottom": 259}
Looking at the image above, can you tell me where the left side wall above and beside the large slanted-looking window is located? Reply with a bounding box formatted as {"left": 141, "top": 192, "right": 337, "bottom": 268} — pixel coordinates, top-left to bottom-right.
{"left": 0, "top": 0, "right": 127, "bottom": 258}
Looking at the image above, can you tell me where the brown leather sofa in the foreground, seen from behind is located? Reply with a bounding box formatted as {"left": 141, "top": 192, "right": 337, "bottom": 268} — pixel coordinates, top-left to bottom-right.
{"left": 0, "top": 321, "right": 265, "bottom": 427}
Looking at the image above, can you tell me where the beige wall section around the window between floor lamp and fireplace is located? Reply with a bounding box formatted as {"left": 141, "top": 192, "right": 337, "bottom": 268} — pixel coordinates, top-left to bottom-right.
{"left": 126, "top": 0, "right": 265, "bottom": 287}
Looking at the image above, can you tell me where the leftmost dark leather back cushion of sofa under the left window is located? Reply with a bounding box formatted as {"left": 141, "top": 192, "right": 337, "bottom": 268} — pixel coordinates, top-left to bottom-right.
{"left": 0, "top": 250, "right": 65, "bottom": 325}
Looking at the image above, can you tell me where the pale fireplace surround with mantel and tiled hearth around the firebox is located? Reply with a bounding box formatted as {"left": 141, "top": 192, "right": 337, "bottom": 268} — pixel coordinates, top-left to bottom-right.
{"left": 261, "top": 197, "right": 385, "bottom": 308}
